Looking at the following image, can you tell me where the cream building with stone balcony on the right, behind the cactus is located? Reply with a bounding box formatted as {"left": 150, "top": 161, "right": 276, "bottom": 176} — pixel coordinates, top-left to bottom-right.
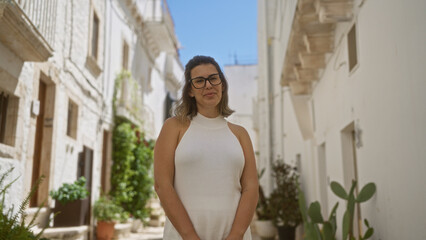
{"left": 258, "top": 0, "right": 426, "bottom": 239}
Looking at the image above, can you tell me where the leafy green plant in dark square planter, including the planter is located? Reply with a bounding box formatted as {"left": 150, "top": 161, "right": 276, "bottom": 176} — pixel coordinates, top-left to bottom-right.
{"left": 50, "top": 177, "right": 90, "bottom": 227}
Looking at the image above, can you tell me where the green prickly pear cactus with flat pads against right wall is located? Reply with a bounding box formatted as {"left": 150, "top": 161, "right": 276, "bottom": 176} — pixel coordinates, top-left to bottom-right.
{"left": 299, "top": 180, "right": 376, "bottom": 240}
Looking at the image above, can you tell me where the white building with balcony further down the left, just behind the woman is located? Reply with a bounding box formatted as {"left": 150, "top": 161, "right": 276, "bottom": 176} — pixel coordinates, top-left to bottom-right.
{"left": 105, "top": 0, "right": 183, "bottom": 139}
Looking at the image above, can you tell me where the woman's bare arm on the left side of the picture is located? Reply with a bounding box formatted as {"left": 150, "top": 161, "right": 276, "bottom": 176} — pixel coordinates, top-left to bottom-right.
{"left": 154, "top": 118, "right": 200, "bottom": 240}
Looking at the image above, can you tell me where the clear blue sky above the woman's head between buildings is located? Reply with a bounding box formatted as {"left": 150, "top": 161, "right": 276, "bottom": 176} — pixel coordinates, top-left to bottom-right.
{"left": 167, "top": 0, "right": 257, "bottom": 67}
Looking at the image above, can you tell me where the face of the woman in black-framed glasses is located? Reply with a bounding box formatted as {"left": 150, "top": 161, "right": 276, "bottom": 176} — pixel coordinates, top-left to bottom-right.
{"left": 189, "top": 63, "right": 223, "bottom": 110}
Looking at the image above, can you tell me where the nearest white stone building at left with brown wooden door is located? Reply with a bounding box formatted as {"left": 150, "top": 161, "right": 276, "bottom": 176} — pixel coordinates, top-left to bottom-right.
{"left": 0, "top": 0, "right": 107, "bottom": 236}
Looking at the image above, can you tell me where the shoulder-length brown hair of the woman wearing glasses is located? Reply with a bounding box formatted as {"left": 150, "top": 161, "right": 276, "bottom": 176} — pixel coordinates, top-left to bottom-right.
{"left": 174, "top": 56, "right": 234, "bottom": 122}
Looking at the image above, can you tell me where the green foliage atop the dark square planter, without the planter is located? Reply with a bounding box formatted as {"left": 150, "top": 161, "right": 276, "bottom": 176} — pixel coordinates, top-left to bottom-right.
{"left": 50, "top": 177, "right": 89, "bottom": 204}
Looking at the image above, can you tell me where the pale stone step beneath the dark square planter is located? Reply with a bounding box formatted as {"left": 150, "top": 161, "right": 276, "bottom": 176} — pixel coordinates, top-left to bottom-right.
{"left": 32, "top": 225, "right": 89, "bottom": 240}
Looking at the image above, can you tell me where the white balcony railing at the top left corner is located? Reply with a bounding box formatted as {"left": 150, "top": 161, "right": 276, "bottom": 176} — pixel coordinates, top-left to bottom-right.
{"left": 15, "top": 0, "right": 58, "bottom": 48}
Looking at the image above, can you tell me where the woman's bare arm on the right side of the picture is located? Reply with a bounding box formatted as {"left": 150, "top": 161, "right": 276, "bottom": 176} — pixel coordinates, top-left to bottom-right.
{"left": 226, "top": 124, "right": 259, "bottom": 240}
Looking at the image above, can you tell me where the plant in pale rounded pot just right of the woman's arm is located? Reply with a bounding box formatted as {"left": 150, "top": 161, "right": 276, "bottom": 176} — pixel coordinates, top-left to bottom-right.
{"left": 254, "top": 169, "right": 277, "bottom": 239}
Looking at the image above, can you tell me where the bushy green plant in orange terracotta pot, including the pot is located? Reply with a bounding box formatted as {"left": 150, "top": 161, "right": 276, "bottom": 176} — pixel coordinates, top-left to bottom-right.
{"left": 93, "top": 196, "right": 124, "bottom": 240}
